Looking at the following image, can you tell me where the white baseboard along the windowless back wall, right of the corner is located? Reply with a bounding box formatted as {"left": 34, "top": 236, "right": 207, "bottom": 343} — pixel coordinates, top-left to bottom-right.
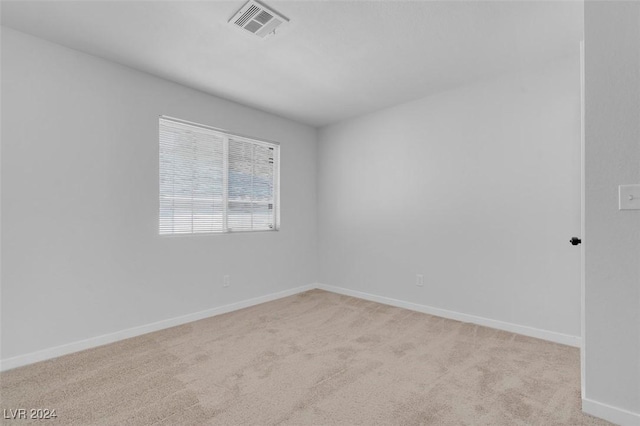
{"left": 316, "top": 284, "right": 582, "bottom": 348}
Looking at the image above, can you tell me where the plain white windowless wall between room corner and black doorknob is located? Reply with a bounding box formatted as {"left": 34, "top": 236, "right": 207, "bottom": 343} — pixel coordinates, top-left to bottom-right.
{"left": 318, "top": 56, "right": 580, "bottom": 341}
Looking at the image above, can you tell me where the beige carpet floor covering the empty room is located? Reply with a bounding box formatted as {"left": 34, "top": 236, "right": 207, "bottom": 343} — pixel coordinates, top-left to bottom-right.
{"left": 0, "top": 290, "right": 608, "bottom": 426}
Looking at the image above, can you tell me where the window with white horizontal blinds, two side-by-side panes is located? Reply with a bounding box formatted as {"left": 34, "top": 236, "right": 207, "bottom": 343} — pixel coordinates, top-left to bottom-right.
{"left": 159, "top": 117, "right": 280, "bottom": 235}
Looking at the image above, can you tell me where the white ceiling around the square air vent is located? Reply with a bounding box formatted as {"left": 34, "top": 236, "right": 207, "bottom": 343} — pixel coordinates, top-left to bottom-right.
{"left": 1, "top": 0, "right": 583, "bottom": 126}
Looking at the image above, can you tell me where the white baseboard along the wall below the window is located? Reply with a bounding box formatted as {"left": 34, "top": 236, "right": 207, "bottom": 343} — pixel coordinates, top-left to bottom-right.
{"left": 0, "top": 285, "right": 315, "bottom": 371}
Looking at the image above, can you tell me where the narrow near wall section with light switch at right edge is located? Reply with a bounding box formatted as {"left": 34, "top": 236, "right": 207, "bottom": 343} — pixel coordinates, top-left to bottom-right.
{"left": 583, "top": 1, "right": 640, "bottom": 425}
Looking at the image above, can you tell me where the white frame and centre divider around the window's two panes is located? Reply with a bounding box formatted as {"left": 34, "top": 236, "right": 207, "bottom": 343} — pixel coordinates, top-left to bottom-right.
{"left": 156, "top": 115, "right": 280, "bottom": 237}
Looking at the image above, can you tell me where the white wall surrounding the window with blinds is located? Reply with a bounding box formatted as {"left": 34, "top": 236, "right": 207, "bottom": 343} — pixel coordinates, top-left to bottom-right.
{"left": 1, "top": 28, "right": 317, "bottom": 359}
